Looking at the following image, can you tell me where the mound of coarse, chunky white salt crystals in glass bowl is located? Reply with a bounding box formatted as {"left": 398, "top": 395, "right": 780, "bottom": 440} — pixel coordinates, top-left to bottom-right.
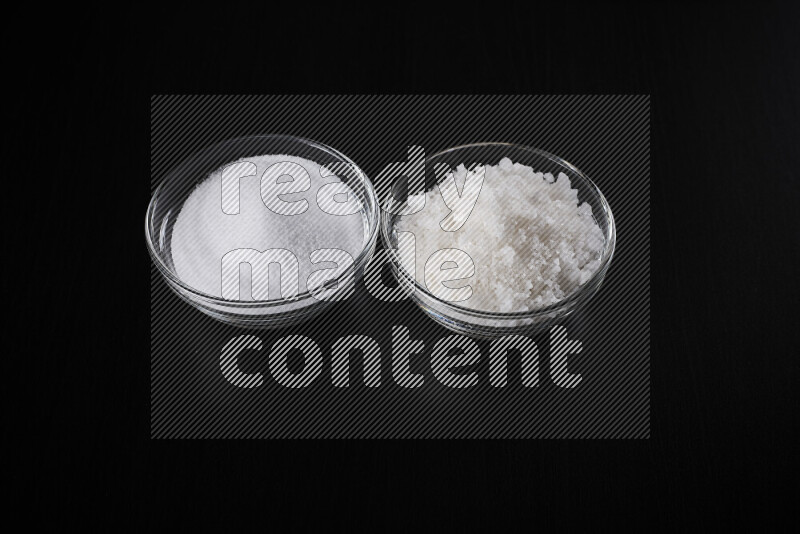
{"left": 396, "top": 158, "right": 604, "bottom": 313}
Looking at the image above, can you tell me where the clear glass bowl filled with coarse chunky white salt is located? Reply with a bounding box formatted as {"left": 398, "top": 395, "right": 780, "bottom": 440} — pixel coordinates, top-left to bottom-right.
{"left": 381, "top": 143, "right": 616, "bottom": 338}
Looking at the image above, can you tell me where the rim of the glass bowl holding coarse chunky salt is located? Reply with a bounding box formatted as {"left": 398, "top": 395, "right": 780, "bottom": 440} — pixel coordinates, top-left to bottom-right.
{"left": 381, "top": 142, "right": 617, "bottom": 319}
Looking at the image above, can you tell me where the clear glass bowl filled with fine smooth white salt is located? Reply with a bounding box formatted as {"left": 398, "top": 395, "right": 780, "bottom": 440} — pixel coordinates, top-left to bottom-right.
{"left": 145, "top": 135, "right": 379, "bottom": 327}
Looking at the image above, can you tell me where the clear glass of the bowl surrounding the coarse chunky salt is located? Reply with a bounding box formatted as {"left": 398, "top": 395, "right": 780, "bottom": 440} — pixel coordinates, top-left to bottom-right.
{"left": 381, "top": 143, "right": 616, "bottom": 338}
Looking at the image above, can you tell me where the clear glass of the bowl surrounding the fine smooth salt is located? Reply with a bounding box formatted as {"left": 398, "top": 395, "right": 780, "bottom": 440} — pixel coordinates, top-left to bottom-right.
{"left": 145, "top": 135, "right": 379, "bottom": 328}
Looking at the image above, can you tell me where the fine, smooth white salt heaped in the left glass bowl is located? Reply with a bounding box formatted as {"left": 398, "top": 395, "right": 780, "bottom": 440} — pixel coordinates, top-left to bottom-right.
{"left": 171, "top": 155, "right": 365, "bottom": 300}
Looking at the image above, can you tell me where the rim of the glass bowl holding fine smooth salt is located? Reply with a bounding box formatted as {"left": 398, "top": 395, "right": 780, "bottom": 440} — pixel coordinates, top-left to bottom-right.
{"left": 144, "top": 134, "right": 381, "bottom": 313}
